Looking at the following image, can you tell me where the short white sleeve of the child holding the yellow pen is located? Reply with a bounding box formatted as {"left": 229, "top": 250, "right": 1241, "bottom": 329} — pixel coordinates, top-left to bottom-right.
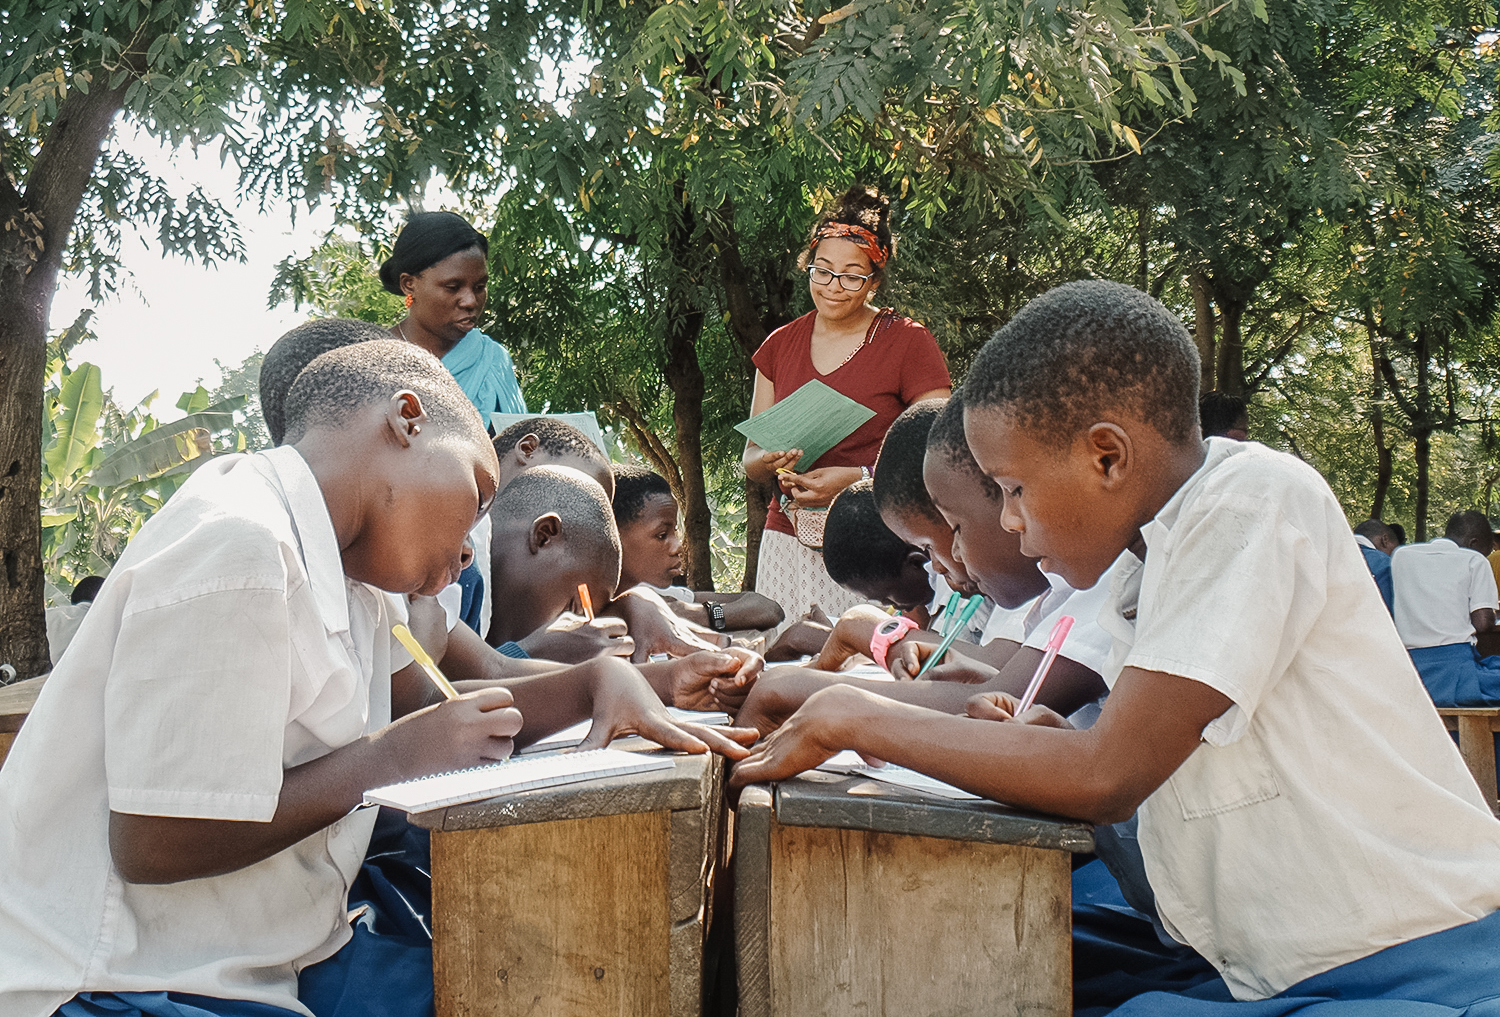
{"left": 104, "top": 575, "right": 296, "bottom": 822}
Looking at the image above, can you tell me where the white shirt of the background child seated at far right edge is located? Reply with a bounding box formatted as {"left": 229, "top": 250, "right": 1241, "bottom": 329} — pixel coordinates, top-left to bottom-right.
{"left": 1391, "top": 537, "right": 1500, "bottom": 650}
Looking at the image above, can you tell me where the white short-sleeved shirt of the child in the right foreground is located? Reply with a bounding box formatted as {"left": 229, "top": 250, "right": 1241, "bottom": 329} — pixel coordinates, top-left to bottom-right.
{"left": 1101, "top": 438, "right": 1500, "bottom": 999}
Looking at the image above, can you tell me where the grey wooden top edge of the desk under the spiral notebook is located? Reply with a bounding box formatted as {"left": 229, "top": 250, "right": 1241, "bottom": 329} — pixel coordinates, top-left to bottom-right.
{"left": 410, "top": 750, "right": 723, "bottom": 831}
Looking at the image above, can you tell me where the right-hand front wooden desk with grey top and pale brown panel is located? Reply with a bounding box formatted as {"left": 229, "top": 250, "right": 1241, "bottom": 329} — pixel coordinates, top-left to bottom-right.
{"left": 735, "top": 773, "right": 1094, "bottom": 1017}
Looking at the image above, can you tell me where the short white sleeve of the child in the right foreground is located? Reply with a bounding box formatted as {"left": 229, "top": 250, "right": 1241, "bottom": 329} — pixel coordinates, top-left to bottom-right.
{"left": 1124, "top": 492, "right": 1328, "bottom": 746}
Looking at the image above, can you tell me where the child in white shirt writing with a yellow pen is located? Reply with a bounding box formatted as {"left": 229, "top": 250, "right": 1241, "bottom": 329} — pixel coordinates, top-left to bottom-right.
{"left": 0, "top": 341, "right": 750, "bottom": 1017}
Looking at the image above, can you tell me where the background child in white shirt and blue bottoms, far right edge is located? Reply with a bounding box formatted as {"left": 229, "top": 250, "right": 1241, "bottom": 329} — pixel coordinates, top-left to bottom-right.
{"left": 1391, "top": 512, "right": 1500, "bottom": 707}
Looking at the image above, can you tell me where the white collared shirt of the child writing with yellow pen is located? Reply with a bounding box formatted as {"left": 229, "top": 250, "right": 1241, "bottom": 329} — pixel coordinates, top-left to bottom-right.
{"left": 0, "top": 446, "right": 392, "bottom": 1017}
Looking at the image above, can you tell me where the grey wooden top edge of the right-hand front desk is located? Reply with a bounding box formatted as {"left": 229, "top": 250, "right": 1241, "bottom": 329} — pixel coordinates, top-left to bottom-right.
{"left": 768, "top": 771, "right": 1094, "bottom": 854}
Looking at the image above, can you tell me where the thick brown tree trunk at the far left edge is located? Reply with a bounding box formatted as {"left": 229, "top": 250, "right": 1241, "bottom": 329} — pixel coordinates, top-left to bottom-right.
{"left": 0, "top": 77, "right": 132, "bottom": 678}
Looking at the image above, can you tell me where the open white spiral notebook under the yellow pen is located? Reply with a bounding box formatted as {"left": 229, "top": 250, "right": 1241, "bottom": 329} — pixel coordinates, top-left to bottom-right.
{"left": 365, "top": 749, "right": 677, "bottom": 813}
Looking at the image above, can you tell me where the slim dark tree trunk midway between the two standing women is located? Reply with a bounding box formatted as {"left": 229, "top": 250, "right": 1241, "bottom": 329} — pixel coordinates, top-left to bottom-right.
{"left": 666, "top": 185, "right": 714, "bottom": 590}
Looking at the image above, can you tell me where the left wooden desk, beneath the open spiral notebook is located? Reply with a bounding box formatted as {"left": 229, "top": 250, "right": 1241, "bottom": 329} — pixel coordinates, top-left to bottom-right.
{"left": 413, "top": 750, "right": 725, "bottom": 1017}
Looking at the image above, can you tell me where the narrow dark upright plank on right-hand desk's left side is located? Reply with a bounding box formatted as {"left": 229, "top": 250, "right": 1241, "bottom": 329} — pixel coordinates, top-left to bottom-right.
{"left": 735, "top": 785, "right": 771, "bottom": 1017}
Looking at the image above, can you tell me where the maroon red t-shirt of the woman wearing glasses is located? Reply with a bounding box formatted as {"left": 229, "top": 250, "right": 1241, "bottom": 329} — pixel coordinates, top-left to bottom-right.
{"left": 752, "top": 308, "right": 953, "bottom": 534}
